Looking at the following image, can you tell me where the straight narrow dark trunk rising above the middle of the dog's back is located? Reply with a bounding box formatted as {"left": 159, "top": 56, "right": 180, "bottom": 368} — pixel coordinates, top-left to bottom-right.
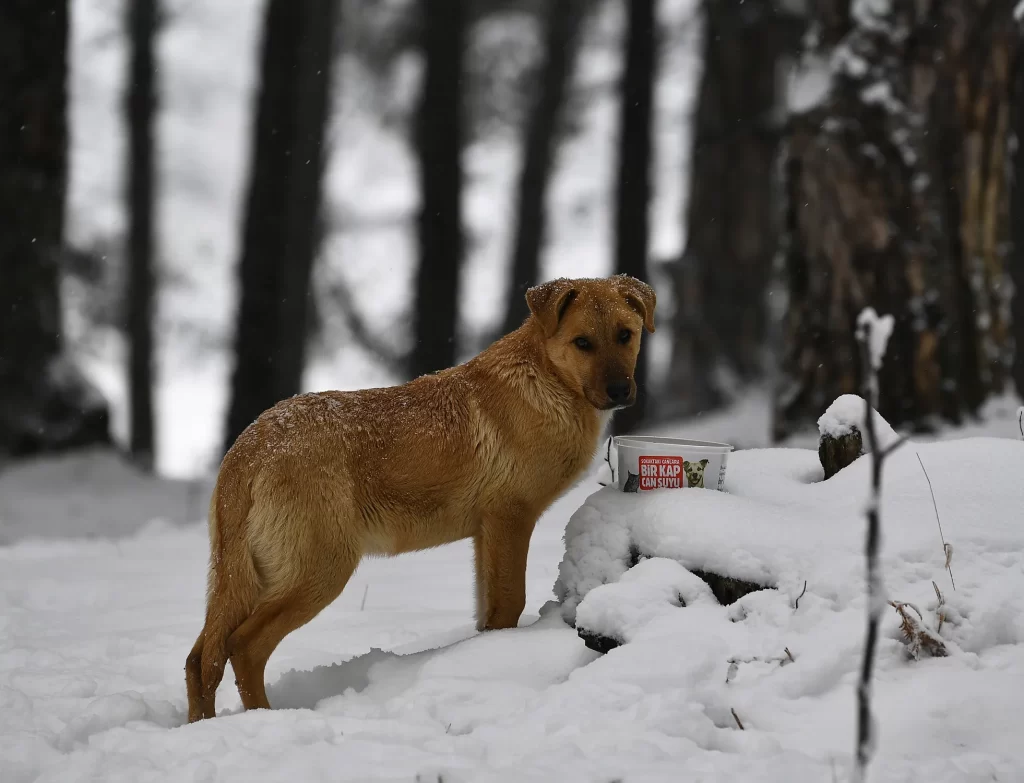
{"left": 410, "top": 0, "right": 466, "bottom": 376}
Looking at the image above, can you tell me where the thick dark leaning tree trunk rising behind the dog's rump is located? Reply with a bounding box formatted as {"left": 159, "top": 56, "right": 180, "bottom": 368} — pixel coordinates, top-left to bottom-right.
{"left": 224, "top": 0, "right": 338, "bottom": 449}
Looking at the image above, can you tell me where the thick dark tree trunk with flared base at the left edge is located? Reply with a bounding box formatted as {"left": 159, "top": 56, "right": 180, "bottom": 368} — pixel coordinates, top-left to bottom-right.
{"left": 0, "top": 0, "right": 110, "bottom": 458}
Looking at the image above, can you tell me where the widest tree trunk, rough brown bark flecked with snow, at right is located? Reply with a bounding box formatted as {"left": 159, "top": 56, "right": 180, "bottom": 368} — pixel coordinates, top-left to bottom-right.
{"left": 773, "top": 0, "right": 1017, "bottom": 438}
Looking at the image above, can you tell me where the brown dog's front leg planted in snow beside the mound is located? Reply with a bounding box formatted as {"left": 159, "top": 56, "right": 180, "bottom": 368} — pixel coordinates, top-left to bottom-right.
{"left": 473, "top": 509, "right": 537, "bottom": 630}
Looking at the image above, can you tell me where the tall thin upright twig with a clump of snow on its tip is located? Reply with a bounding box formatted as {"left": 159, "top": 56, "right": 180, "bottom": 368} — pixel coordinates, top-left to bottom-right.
{"left": 853, "top": 307, "right": 893, "bottom": 783}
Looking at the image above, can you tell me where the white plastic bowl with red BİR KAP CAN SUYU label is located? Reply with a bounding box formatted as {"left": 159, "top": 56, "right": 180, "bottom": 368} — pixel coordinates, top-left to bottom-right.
{"left": 613, "top": 435, "right": 732, "bottom": 492}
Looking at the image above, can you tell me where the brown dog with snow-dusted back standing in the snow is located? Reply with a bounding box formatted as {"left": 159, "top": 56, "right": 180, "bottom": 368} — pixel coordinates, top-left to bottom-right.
{"left": 185, "top": 276, "right": 655, "bottom": 721}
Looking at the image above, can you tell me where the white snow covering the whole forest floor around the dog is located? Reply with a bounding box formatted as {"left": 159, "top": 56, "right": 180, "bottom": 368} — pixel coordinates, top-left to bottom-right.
{"left": 0, "top": 411, "right": 1024, "bottom": 783}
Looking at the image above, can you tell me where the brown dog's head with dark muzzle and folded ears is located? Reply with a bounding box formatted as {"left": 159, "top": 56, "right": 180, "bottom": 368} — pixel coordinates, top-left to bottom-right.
{"left": 526, "top": 274, "right": 655, "bottom": 410}
